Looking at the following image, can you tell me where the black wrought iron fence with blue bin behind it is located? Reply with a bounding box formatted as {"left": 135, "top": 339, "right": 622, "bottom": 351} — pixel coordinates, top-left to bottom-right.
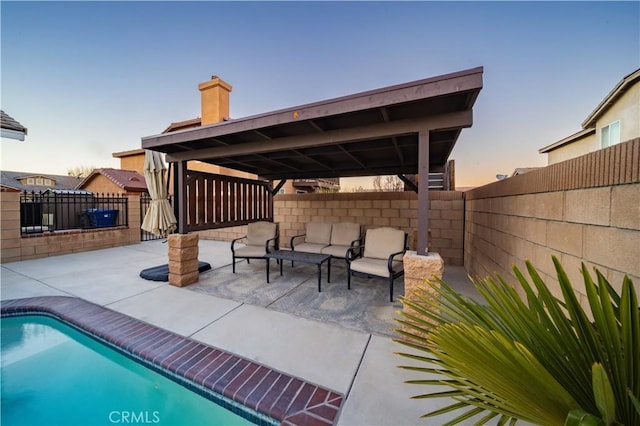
{"left": 20, "top": 189, "right": 129, "bottom": 235}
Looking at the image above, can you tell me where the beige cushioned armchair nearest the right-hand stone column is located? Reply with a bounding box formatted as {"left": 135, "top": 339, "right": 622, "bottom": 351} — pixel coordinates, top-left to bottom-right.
{"left": 347, "top": 228, "right": 407, "bottom": 302}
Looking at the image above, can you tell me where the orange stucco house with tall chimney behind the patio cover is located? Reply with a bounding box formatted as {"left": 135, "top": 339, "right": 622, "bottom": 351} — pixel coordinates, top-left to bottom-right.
{"left": 112, "top": 75, "right": 340, "bottom": 194}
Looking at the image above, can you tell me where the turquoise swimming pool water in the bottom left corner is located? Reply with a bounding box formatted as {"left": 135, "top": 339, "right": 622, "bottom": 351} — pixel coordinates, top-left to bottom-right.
{"left": 0, "top": 316, "right": 252, "bottom": 426}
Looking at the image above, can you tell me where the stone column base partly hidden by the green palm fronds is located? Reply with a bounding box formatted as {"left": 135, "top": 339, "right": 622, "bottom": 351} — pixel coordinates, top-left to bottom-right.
{"left": 402, "top": 251, "right": 444, "bottom": 335}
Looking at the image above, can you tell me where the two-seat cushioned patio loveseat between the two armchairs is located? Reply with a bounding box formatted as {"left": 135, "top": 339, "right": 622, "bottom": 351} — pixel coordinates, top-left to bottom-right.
{"left": 291, "top": 222, "right": 362, "bottom": 259}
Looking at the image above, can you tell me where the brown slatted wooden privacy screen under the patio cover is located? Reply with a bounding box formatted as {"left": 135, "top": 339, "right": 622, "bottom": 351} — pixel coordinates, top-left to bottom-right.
{"left": 185, "top": 170, "right": 273, "bottom": 231}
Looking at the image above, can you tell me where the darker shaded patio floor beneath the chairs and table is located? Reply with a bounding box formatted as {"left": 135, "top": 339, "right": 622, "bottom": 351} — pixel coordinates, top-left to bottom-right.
{"left": 185, "top": 240, "right": 477, "bottom": 337}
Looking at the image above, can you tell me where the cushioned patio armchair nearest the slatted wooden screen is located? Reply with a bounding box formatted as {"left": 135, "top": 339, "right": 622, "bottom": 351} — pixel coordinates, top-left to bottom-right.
{"left": 231, "top": 222, "right": 279, "bottom": 274}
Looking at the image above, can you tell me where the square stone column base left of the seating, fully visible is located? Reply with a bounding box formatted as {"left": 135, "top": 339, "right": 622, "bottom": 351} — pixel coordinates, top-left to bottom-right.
{"left": 168, "top": 234, "right": 200, "bottom": 287}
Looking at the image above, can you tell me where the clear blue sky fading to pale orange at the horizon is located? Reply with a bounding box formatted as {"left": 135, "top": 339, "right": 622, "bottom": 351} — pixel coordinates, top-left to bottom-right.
{"left": 0, "top": 0, "right": 640, "bottom": 187}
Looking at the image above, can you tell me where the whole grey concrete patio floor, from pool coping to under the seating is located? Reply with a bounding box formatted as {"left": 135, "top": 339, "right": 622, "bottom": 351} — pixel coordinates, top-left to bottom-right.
{"left": 0, "top": 240, "right": 484, "bottom": 425}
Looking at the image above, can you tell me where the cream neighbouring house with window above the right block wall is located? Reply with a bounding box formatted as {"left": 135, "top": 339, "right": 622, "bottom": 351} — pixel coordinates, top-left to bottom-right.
{"left": 538, "top": 69, "right": 640, "bottom": 164}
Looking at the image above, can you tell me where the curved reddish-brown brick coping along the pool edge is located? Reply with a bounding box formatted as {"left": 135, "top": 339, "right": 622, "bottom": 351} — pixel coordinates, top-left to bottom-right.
{"left": 0, "top": 296, "right": 344, "bottom": 426}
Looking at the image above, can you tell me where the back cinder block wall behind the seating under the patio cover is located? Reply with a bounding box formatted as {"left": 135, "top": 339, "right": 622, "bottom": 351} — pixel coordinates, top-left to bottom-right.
{"left": 199, "top": 191, "right": 464, "bottom": 265}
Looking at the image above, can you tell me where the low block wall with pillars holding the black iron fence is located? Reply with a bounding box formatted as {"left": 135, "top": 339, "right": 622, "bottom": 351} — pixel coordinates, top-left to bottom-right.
{"left": 0, "top": 192, "right": 141, "bottom": 263}
